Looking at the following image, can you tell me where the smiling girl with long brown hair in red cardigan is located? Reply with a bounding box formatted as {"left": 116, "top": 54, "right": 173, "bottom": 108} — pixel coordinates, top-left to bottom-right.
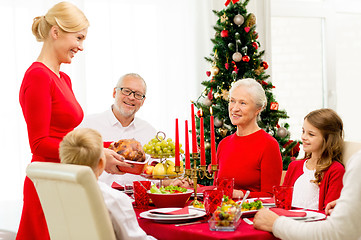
{"left": 283, "top": 109, "right": 345, "bottom": 211}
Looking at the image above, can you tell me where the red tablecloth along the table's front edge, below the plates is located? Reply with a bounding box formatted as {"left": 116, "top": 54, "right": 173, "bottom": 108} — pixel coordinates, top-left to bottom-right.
{"left": 134, "top": 206, "right": 278, "bottom": 240}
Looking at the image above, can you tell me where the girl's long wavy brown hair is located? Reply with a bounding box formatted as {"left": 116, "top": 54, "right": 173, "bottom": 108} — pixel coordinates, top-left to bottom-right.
{"left": 304, "top": 108, "right": 344, "bottom": 184}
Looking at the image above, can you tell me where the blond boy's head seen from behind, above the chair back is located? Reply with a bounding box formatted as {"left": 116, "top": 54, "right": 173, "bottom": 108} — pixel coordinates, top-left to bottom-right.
{"left": 59, "top": 128, "right": 105, "bottom": 177}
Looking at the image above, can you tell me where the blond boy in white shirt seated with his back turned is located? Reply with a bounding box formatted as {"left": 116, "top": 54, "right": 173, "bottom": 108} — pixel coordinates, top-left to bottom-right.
{"left": 59, "top": 128, "right": 154, "bottom": 240}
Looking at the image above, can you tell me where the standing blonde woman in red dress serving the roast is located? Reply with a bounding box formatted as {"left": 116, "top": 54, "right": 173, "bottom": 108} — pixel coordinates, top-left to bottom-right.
{"left": 16, "top": 2, "right": 126, "bottom": 240}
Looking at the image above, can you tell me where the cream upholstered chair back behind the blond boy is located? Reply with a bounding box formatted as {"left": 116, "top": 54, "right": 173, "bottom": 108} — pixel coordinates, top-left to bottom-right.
{"left": 26, "top": 162, "right": 115, "bottom": 240}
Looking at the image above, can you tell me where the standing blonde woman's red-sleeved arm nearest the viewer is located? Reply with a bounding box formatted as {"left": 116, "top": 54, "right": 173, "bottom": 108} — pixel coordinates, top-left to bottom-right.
{"left": 22, "top": 70, "right": 61, "bottom": 158}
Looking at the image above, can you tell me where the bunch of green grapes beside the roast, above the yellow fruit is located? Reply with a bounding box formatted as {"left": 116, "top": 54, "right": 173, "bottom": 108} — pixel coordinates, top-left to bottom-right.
{"left": 143, "top": 136, "right": 184, "bottom": 158}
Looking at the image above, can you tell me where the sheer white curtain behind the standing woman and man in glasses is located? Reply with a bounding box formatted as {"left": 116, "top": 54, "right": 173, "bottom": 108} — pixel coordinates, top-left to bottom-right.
{"left": 0, "top": 0, "right": 215, "bottom": 231}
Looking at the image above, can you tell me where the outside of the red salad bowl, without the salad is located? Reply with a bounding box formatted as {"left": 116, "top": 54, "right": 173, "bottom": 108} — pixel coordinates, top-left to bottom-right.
{"left": 148, "top": 189, "right": 193, "bottom": 208}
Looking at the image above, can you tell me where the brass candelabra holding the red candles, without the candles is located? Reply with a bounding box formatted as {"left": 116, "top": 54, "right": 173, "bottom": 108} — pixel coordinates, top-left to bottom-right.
{"left": 184, "top": 153, "right": 218, "bottom": 206}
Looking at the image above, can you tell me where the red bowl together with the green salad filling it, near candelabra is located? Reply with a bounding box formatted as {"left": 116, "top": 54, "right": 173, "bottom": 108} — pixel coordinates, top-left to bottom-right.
{"left": 148, "top": 185, "right": 193, "bottom": 208}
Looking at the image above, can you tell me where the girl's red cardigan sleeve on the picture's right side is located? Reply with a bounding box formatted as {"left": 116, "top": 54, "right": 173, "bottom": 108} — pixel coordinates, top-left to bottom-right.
{"left": 319, "top": 164, "right": 345, "bottom": 210}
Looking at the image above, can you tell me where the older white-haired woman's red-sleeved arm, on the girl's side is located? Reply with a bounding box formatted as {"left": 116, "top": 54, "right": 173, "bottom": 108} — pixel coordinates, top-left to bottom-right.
{"left": 249, "top": 141, "right": 282, "bottom": 198}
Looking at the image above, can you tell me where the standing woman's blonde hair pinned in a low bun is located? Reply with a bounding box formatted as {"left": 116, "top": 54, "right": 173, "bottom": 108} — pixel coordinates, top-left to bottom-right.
{"left": 32, "top": 2, "right": 89, "bottom": 42}
